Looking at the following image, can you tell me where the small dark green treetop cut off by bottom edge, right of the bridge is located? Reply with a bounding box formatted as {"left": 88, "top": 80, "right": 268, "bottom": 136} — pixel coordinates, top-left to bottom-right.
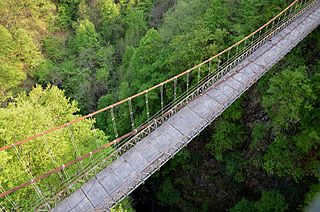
{"left": 255, "top": 191, "right": 288, "bottom": 212}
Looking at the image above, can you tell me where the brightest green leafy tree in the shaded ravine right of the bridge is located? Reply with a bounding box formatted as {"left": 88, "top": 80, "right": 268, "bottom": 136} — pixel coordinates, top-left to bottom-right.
{"left": 263, "top": 66, "right": 315, "bottom": 131}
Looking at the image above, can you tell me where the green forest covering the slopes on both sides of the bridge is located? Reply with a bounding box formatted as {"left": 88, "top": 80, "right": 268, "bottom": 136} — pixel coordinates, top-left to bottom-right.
{"left": 0, "top": 0, "right": 320, "bottom": 212}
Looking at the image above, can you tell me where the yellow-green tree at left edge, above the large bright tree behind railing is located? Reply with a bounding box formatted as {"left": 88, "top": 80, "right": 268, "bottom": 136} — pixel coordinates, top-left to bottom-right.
{"left": 0, "top": 25, "right": 42, "bottom": 102}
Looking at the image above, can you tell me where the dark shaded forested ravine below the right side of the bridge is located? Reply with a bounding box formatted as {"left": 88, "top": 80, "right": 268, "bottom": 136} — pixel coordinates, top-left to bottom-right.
{"left": 131, "top": 26, "right": 320, "bottom": 211}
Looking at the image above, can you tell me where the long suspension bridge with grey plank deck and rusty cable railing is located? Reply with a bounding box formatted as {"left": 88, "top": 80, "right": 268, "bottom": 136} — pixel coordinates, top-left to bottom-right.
{"left": 0, "top": 0, "right": 320, "bottom": 211}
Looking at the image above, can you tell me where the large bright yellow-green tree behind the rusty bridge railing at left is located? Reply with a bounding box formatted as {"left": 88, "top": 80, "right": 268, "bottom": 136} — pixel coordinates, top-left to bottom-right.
{"left": 0, "top": 86, "right": 107, "bottom": 208}
